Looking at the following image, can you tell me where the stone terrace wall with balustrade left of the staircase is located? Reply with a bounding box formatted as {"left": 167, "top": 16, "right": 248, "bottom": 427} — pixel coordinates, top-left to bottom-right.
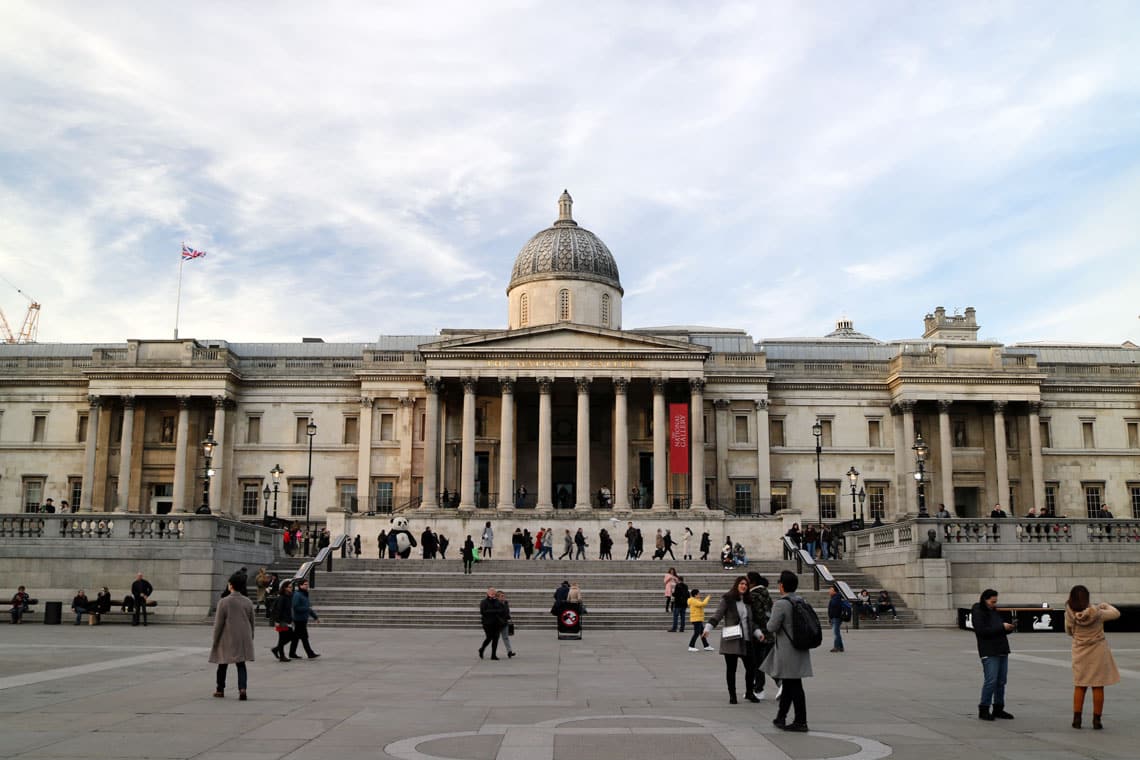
{"left": 0, "top": 513, "right": 280, "bottom": 622}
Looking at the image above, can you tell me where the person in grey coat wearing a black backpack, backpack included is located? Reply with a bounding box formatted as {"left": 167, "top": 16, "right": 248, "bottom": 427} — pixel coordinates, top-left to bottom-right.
{"left": 760, "top": 570, "right": 823, "bottom": 733}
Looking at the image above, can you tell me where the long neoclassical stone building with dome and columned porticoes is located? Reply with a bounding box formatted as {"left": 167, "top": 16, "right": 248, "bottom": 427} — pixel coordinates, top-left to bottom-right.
{"left": 0, "top": 193, "right": 1140, "bottom": 522}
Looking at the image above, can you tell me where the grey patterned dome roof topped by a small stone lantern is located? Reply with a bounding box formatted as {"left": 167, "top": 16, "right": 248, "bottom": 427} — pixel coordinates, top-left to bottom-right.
{"left": 506, "top": 190, "right": 625, "bottom": 294}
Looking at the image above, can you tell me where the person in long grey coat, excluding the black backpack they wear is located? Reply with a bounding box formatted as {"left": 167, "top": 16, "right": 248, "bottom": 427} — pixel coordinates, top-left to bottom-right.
{"left": 760, "top": 570, "right": 812, "bottom": 733}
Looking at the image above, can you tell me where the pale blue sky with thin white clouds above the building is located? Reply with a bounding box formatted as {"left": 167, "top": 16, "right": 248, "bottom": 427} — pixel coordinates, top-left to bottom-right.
{"left": 0, "top": 0, "right": 1140, "bottom": 344}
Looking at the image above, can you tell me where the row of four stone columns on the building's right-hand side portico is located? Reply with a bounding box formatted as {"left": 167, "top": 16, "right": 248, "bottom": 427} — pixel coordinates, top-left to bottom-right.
{"left": 895, "top": 400, "right": 1045, "bottom": 513}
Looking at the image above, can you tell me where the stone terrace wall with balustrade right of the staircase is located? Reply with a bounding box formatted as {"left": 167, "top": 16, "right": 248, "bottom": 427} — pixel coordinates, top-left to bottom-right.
{"left": 847, "top": 518, "right": 1140, "bottom": 626}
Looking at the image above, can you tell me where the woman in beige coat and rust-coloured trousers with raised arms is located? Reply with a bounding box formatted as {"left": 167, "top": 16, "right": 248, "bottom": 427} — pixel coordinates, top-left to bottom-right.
{"left": 1065, "top": 586, "right": 1121, "bottom": 728}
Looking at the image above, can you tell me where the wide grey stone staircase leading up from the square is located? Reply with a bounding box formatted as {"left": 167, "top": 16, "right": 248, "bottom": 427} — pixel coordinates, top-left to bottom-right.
{"left": 262, "top": 557, "right": 921, "bottom": 630}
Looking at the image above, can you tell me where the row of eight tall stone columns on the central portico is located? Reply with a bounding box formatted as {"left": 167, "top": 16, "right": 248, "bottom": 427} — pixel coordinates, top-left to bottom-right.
{"left": 422, "top": 377, "right": 720, "bottom": 509}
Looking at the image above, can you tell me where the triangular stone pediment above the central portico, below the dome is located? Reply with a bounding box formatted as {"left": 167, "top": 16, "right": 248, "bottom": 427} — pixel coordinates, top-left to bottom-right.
{"left": 420, "top": 325, "right": 710, "bottom": 359}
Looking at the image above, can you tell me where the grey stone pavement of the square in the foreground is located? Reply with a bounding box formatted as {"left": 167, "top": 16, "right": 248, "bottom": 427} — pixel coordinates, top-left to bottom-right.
{"left": 0, "top": 624, "right": 1140, "bottom": 760}
